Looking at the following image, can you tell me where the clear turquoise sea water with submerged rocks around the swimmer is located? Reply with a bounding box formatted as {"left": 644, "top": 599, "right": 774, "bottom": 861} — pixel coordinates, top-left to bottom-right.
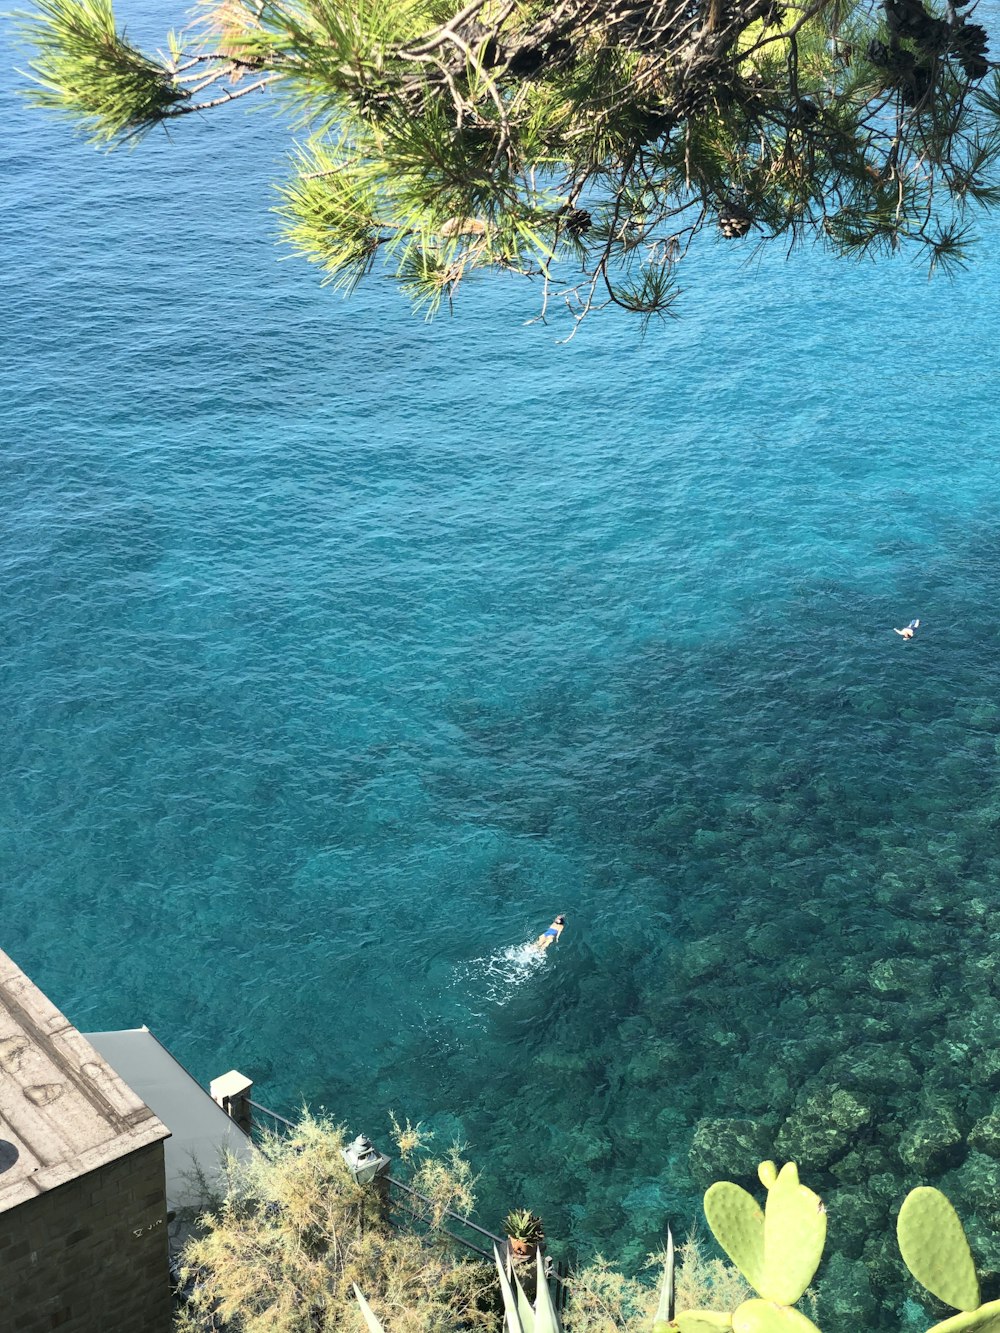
{"left": 0, "top": 0, "right": 1000, "bottom": 1328}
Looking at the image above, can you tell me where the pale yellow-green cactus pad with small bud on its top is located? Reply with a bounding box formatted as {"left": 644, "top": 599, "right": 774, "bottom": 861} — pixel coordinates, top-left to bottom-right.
{"left": 753, "top": 1162, "right": 827, "bottom": 1305}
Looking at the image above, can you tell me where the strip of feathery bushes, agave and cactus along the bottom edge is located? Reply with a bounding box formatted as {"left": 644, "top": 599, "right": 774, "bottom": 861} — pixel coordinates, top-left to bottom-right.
{"left": 175, "top": 1113, "right": 1000, "bottom": 1333}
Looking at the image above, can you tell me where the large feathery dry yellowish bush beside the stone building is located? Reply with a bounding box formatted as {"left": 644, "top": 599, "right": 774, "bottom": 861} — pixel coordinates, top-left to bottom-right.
{"left": 176, "top": 1114, "right": 495, "bottom": 1333}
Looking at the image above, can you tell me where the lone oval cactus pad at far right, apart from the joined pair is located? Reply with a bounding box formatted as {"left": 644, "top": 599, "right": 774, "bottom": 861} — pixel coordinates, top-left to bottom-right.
{"left": 896, "top": 1185, "right": 981, "bottom": 1311}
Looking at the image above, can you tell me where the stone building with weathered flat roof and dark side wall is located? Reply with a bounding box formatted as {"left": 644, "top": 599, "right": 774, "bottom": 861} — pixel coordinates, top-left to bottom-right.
{"left": 0, "top": 952, "right": 172, "bottom": 1333}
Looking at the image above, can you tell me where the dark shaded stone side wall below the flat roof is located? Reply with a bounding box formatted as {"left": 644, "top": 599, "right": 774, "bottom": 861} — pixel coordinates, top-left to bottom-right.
{"left": 0, "top": 1142, "right": 171, "bottom": 1333}
